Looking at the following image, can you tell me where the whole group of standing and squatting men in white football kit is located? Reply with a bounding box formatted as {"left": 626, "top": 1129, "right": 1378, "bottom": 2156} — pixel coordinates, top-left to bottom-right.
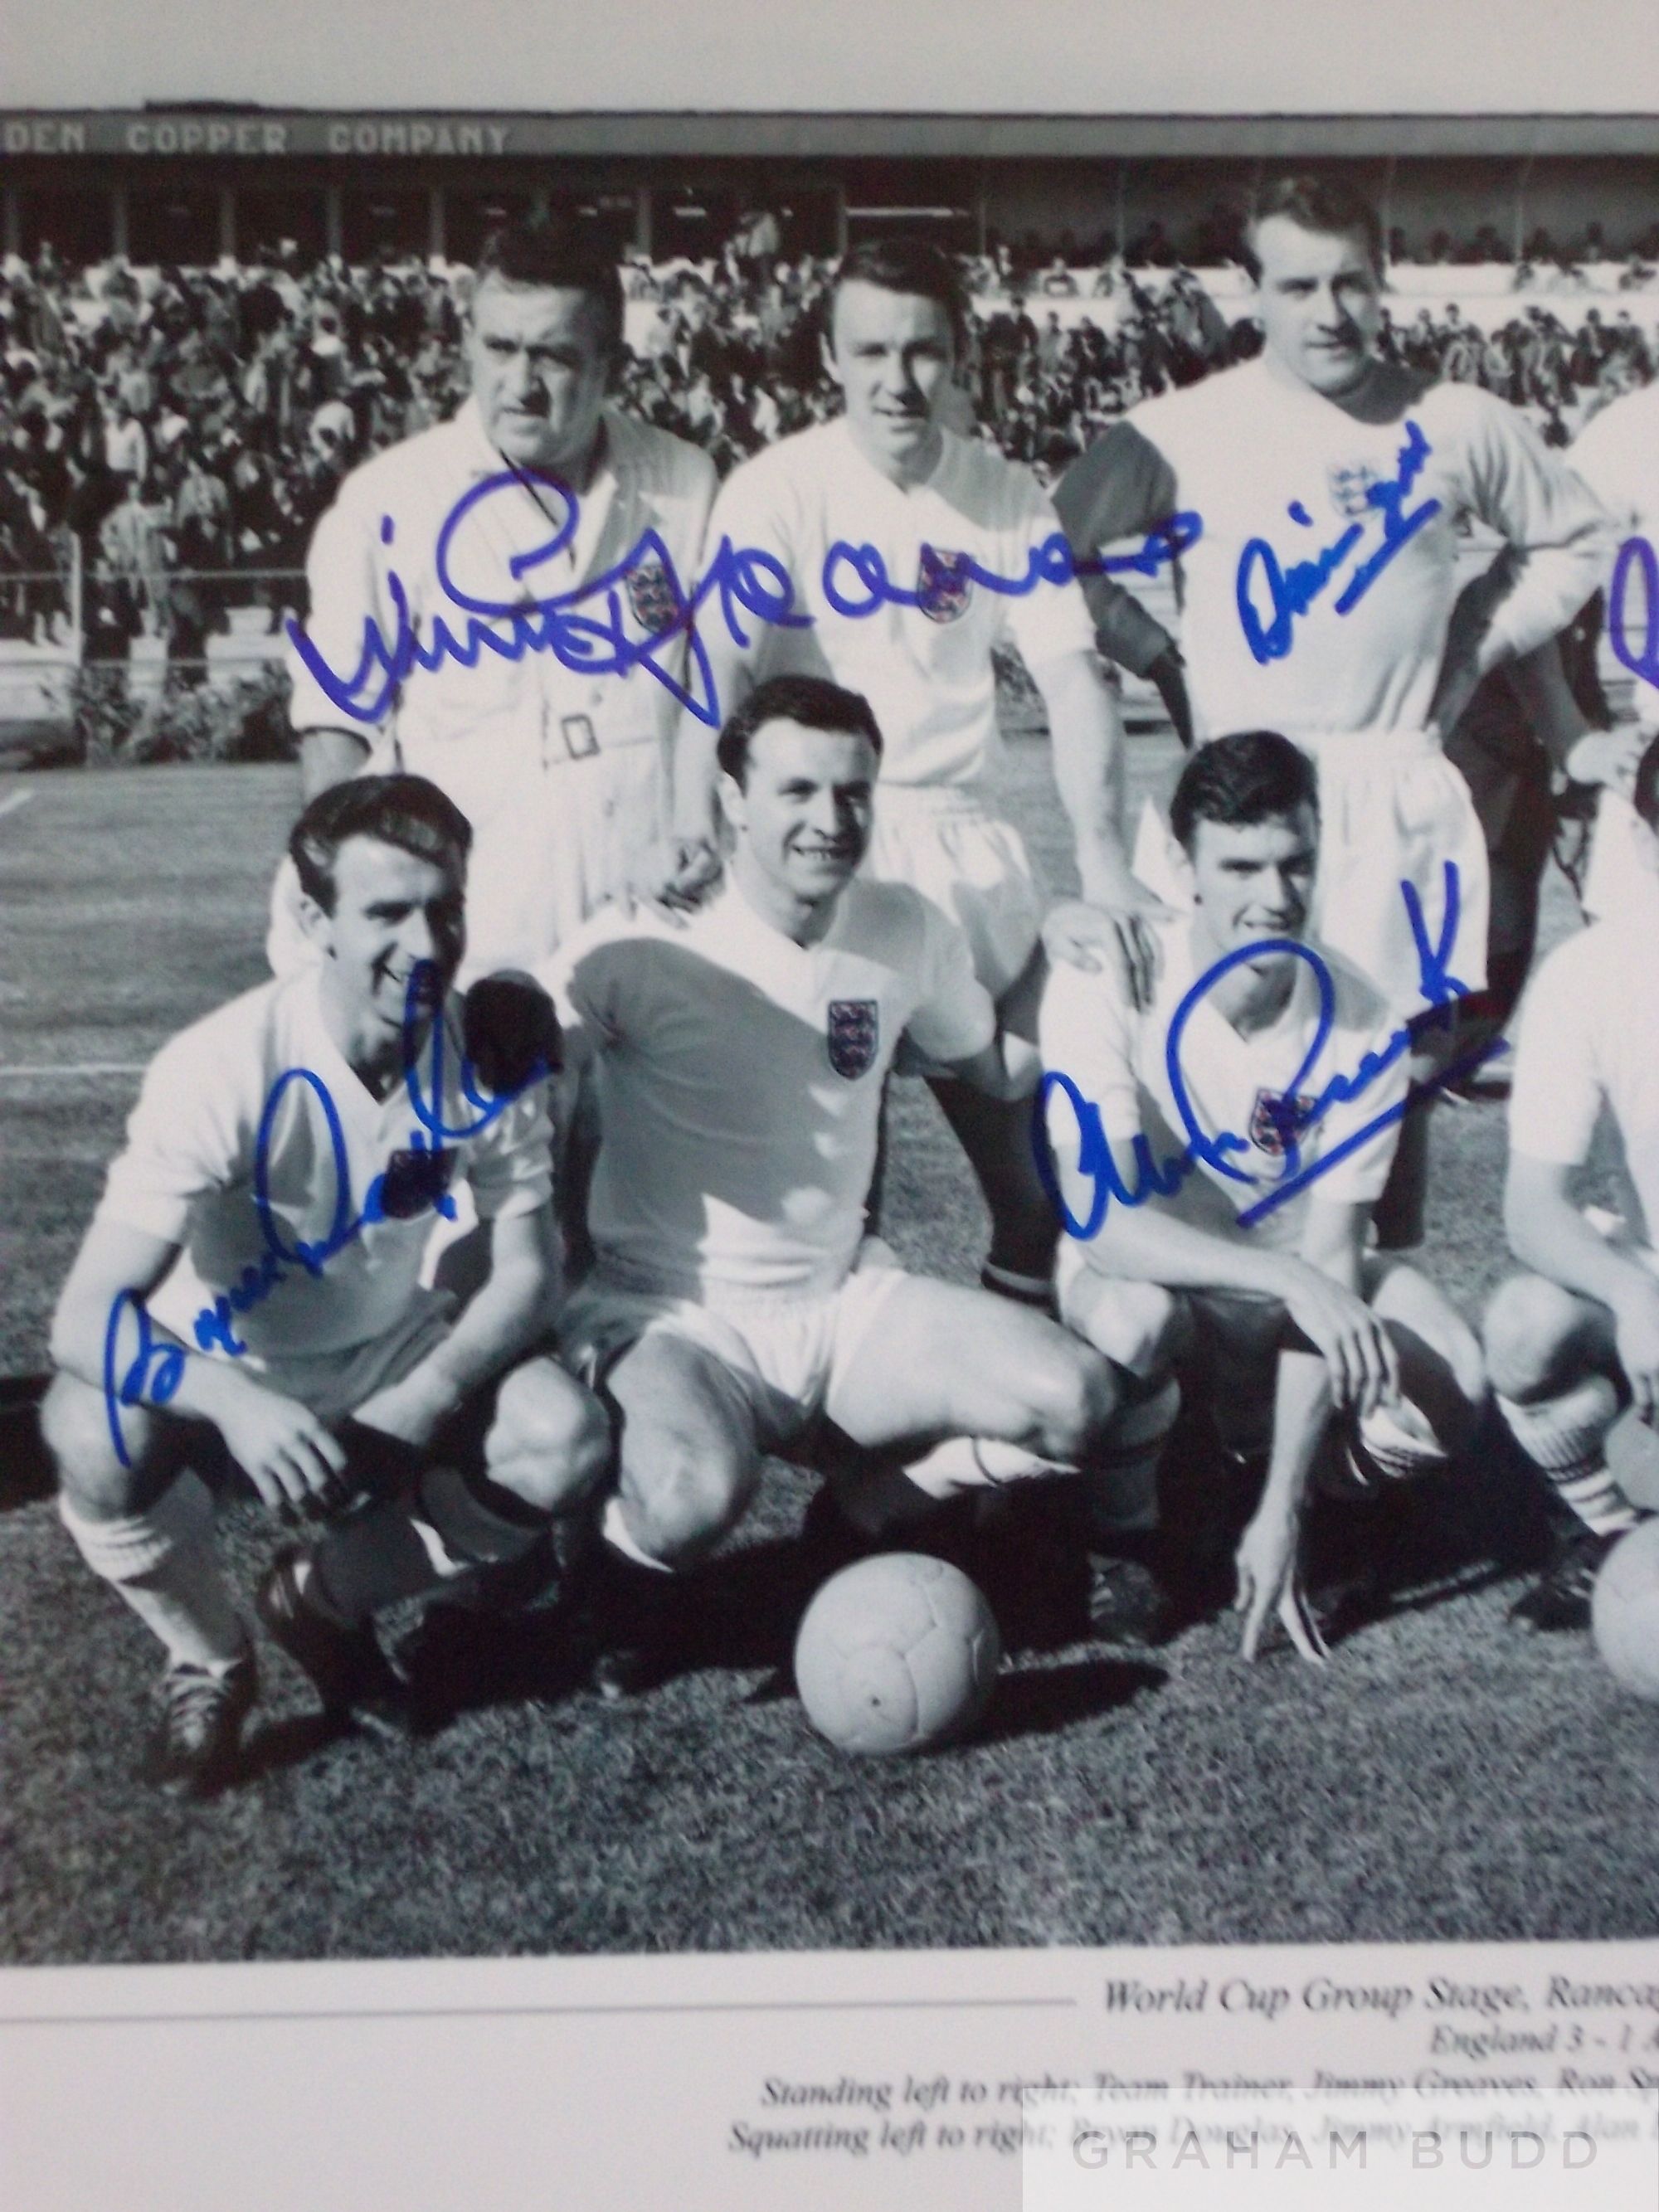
{"left": 44, "top": 179, "right": 1659, "bottom": 1794}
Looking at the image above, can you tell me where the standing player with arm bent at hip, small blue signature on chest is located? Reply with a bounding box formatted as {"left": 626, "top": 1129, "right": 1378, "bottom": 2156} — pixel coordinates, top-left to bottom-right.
{"left": 1055, "top": 177, "right": 1608, "bottom": 1246}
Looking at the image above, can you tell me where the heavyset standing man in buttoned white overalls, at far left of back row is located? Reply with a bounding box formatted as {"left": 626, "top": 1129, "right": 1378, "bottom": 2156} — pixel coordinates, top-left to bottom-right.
{"left": 272, "top": 223, "right": 714, "bottom": 975}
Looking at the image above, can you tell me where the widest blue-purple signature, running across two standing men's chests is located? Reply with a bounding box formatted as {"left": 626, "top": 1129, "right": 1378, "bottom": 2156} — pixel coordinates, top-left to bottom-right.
{"left": 288, "top": 469, "right": 1204, "bottom": 730}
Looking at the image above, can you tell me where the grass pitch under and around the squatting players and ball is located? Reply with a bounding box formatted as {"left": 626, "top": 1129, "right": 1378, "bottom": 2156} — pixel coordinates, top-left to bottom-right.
{"left": 0, "top": 739, "right": 1659, "bottom": 1962}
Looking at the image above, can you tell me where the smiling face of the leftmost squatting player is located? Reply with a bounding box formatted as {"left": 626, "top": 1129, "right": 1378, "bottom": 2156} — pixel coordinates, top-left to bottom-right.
{"left": 312, "top": 836, "right": 467, "bottom": 1057}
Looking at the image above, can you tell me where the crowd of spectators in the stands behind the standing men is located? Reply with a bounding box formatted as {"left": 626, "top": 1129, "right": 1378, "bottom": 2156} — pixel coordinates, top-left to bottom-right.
{"left": 0, "top": 223, "right": 1659, "bottom": 668}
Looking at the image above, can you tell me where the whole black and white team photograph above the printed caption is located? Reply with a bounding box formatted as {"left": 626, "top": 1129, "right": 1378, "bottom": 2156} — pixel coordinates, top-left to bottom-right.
{"left": 0, "top": 0, "right": 1659, "bottom": 2008}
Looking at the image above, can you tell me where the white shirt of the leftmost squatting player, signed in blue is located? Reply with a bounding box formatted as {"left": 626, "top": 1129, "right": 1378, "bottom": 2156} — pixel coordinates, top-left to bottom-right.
{"left": 97, "top": 969, "right": 553, "bottom": 1359}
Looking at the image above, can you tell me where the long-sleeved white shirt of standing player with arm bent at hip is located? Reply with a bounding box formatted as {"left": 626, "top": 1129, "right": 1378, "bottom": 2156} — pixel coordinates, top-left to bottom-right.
{"left": 1059, "top": 356, "right": 1610, "bottom": 739}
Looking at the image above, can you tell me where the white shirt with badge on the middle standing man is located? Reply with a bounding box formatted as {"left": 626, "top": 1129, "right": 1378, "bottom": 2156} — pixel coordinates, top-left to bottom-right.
{"left": 701, "top": 416, "right": 1095, "bottom": 783}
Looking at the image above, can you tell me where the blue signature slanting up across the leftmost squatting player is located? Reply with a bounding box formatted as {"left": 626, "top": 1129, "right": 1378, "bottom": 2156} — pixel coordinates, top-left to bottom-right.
{"left": 104, "top": 960, "right": 548, "bottom": 1466}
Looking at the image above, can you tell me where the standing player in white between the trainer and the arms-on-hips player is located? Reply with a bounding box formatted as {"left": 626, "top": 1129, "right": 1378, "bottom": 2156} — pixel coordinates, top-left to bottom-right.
{"left": 670, "top": 239, "right": 1152, "bottom": 1300}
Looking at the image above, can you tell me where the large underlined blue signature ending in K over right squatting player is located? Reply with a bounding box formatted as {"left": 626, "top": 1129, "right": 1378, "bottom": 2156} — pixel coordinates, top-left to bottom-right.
{"left": 1031, "top": 860, "right": 1509, "bottom": 1243}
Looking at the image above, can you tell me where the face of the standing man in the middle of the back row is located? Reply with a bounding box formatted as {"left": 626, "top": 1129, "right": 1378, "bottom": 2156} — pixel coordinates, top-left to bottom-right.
{"left": 825, "top": 276, "right": 956, "bottom": 480}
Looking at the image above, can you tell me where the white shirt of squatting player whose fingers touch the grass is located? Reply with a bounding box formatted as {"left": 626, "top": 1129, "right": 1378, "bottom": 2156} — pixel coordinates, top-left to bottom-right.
{"left": 1038, "top": 918, "right": 1409, "bottom": 1250}
